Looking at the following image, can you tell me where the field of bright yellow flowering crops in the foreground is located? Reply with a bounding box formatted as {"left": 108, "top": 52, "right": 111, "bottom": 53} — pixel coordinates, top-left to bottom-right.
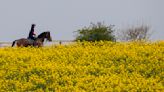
{"left": 0, "top": 42, "right": 164, "bottom": 92}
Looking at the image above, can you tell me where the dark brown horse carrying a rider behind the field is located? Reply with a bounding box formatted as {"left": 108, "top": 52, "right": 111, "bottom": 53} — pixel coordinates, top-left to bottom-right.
{"left": 12, "top": 31, "right": 52, "bottom": 47}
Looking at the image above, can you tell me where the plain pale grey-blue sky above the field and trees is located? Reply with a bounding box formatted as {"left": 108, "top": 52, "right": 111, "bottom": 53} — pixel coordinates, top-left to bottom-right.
{"left": 0, "top": 0, "right": 164, "bottom": 42}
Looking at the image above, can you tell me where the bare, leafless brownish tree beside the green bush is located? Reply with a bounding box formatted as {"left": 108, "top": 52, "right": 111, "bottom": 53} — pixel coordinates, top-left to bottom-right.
{"left": 120, "top": 25, "right": 150, "bottom": 41}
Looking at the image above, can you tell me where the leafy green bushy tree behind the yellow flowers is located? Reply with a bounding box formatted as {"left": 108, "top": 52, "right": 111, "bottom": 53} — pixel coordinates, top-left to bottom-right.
{"left": 76, "top": 22, "right": 116, "bottom": 41}
